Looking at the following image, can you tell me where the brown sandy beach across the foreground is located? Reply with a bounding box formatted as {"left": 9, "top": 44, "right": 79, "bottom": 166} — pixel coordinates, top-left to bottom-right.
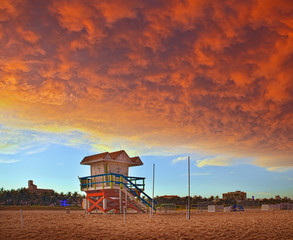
{"left": 0, "top": 210, "right": 293, "bottom": 240}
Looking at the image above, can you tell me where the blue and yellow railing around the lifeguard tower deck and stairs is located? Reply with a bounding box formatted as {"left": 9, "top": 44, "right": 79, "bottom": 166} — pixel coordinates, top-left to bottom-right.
{"left": 79, "top": 173, "right": 157, "bottom": 210}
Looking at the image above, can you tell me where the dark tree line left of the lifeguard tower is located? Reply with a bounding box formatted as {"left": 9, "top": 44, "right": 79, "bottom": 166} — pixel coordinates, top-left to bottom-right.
{"left": 0, "top": 188, "right": 84, "bottom": 206}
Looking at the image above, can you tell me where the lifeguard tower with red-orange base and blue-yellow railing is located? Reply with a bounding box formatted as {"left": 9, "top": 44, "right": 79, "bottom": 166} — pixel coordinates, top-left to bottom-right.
{"left": 79, "top": 150, "right": 155, "bottom": 213}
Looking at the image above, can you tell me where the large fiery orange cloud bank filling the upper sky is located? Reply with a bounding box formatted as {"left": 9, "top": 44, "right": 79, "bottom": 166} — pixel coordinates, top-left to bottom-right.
{"left": 0, "top": 0, "right": 293, "bottom": 169}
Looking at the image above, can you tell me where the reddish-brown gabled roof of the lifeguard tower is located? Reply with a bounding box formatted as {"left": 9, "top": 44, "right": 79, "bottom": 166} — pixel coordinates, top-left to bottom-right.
{"left": 80, "top": 150, "right": 143, "bottom": 167}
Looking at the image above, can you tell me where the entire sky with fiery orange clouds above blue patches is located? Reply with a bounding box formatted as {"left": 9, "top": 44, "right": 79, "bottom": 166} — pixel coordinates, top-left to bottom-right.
{"left": 0, "top": 0, "right": 293, "bottom": 198}
